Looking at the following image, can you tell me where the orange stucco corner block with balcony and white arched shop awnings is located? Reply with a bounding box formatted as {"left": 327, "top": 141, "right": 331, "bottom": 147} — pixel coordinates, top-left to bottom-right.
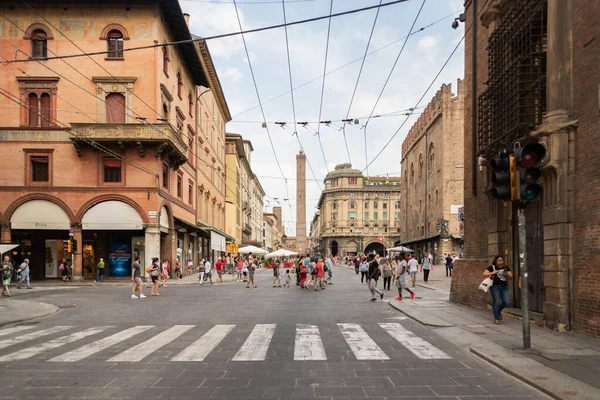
{"left": 0, "top": 0, "right": 231, "bottom": 279}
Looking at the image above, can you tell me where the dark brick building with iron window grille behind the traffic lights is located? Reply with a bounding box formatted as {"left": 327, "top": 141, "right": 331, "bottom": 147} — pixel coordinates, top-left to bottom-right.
{"left": 451, "top": 0, "right": 600, "bottom": 336}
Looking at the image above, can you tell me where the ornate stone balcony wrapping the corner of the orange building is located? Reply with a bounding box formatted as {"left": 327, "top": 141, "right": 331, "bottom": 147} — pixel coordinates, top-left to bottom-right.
{"left": 71, "top": 123, "right": 188, "bottom": 167}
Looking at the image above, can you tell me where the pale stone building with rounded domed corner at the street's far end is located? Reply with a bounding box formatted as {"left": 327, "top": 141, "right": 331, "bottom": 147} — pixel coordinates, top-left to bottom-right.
{"left": 311, "top": 164, "right": 401, "bottom": 256}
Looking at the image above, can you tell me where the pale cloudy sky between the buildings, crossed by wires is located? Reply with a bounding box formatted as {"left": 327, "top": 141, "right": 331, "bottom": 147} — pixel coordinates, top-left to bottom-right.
{"left": 180, "top": 0, "right": 464, "bottom": 236}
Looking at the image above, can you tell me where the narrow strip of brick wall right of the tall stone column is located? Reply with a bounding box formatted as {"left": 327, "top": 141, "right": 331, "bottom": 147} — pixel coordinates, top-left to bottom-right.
{"left": 573, "top": 0, "right": 600, "bottom": 337}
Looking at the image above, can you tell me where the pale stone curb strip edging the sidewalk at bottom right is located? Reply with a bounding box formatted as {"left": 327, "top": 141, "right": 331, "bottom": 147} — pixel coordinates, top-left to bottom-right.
{"left": 469, "top": 343, "right": 600, "bottom": 400}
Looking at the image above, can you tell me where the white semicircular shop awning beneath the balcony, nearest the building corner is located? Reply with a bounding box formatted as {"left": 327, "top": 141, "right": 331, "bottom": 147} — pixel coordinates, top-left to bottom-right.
{"left": 81, "top": 200, "right": 144, "bottom": 230}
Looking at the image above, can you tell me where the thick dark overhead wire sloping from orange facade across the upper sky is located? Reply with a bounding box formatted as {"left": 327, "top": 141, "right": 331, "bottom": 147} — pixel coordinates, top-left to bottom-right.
{"left": 2, "top": 0, "right": 409, "bottom": 63}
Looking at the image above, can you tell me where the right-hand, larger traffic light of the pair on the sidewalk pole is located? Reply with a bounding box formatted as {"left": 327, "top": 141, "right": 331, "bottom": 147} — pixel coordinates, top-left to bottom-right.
{"left": 511, "top": 143, "right": 546, "bottom": 201}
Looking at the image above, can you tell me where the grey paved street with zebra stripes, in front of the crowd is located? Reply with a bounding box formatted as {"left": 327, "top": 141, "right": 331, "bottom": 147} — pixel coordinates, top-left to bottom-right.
{"left": 0, "top": 267, "right": 547, "bottom": 400}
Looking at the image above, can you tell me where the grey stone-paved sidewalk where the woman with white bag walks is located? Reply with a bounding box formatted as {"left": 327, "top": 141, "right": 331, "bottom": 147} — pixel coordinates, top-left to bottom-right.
{"left": 390, "top": 267, "right": 600, "bottom": 399}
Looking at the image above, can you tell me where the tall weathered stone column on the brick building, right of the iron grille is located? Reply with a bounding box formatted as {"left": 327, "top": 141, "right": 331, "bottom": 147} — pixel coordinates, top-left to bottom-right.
{"left": 531, "top": 0, "right": 577, "bottom": 330}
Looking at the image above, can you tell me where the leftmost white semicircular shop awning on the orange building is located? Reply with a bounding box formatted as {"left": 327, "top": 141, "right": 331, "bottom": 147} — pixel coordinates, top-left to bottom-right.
{"left": 10, "top": 200, "right": 71, "bottom": 230}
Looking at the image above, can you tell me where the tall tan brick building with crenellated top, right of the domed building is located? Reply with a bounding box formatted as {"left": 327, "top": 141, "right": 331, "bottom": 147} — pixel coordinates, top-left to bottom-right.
{"left": 400, "top": 80, "right": 465, "bottom": 263}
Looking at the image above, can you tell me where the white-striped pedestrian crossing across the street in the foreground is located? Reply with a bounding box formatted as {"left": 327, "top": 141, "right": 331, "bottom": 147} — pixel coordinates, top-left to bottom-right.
{"left": 0, "top": 323, "right": 452, "bottom": 363}
